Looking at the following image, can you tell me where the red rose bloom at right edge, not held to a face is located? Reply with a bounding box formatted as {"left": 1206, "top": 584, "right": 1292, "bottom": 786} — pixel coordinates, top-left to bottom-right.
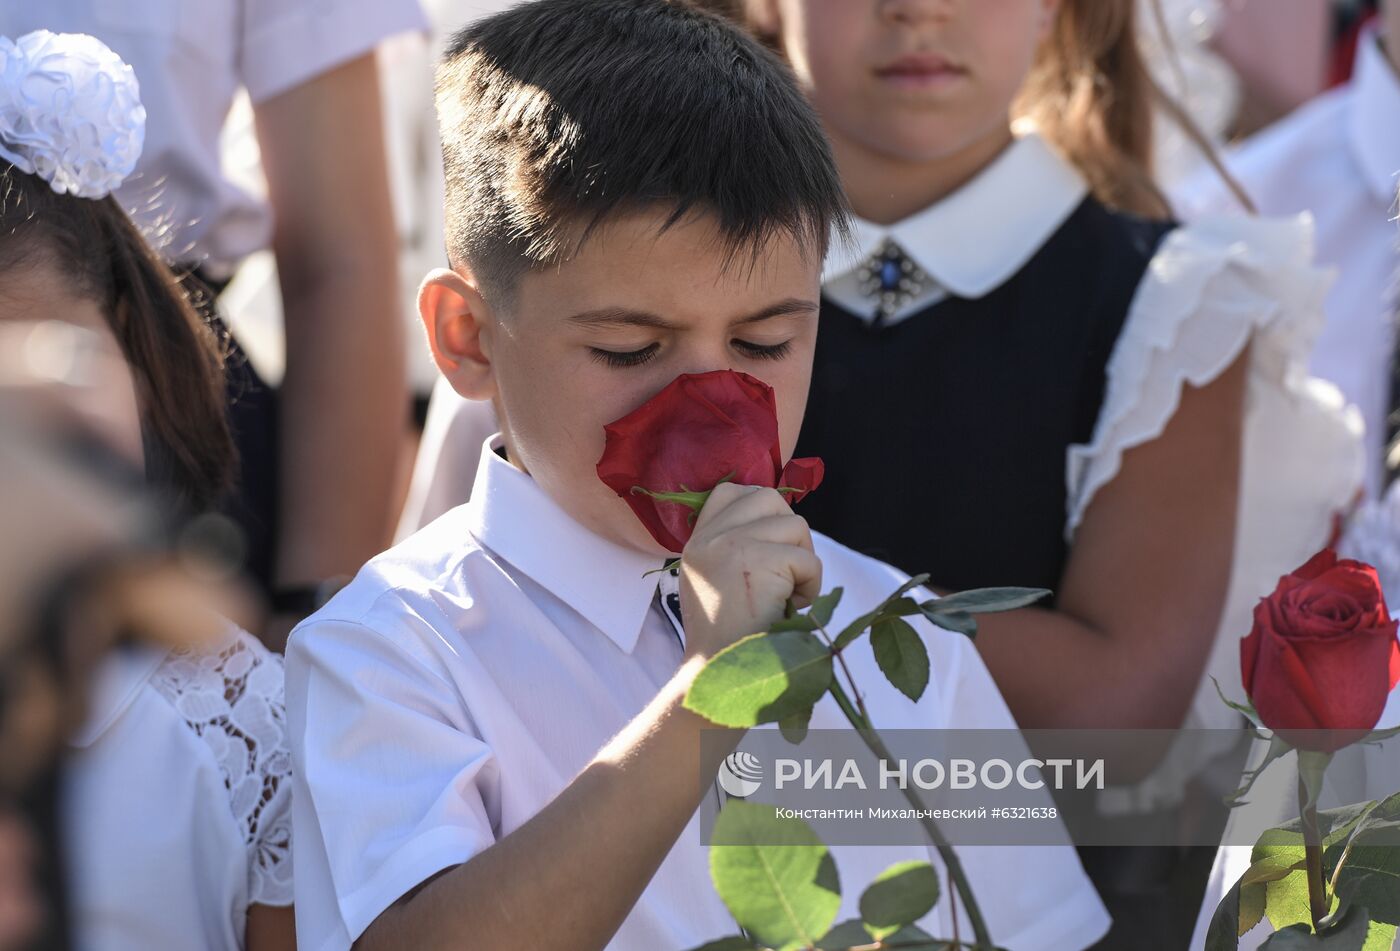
{"left": 1240, "top": 549, "right": 1400, "bottom": 752}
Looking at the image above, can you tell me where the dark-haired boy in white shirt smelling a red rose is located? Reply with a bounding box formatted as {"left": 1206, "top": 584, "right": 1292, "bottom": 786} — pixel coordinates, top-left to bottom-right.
{"left": 287, "top": 0, "right": 1107, "bottom": 951}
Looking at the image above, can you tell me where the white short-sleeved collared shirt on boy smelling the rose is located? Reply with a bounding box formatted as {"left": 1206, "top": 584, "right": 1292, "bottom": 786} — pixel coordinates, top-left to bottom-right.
{"left": 287, "top": 439, "right": 1109, "bottom": 951}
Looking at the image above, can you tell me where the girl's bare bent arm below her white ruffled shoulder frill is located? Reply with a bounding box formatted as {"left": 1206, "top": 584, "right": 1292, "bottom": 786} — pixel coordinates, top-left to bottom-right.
{"left": 977, "top": 350, "right": 1249, "bottom": 745}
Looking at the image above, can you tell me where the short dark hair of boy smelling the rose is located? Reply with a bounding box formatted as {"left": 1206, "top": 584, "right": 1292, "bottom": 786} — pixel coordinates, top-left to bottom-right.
{"left": 437, "top": 0, "right": 846, "bottom": 302}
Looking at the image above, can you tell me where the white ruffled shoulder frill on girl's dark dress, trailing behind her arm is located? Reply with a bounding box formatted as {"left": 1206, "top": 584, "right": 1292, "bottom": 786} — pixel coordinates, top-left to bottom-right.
{"left": 1065, "top": 214, "right": 1365, "bottom": 811}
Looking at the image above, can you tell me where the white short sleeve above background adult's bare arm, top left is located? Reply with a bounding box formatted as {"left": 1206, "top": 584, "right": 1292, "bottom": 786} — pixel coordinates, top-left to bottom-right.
{"left": 238, "top": 0, "right": 427, "bottom": 104}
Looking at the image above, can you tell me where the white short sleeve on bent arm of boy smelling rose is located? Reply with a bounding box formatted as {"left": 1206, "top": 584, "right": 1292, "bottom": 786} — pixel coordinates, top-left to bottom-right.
{"left": 287, "top": 619, "right": 497, "bottom": 951}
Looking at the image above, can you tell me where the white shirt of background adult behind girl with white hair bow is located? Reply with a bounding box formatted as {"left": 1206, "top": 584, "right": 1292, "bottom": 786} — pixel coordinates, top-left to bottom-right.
{"left": 0, "top": 0, "right": 426, "bottom": 277}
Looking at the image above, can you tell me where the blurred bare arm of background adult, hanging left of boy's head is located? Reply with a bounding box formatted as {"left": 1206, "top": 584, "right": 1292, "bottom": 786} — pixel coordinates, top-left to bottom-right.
{"left": 256, "top": 53, "right": 407, "bottom": 585}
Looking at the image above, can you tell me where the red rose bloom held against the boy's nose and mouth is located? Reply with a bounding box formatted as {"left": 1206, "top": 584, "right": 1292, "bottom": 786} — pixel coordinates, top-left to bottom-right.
{"left": 598, "top": 370, "right": 823, "bottom": 553}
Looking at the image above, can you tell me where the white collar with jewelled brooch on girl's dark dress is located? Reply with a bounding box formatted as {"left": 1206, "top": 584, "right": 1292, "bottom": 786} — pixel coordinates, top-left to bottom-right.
{"left": 823, "top": 132, "right": 1089, "bottom": 298}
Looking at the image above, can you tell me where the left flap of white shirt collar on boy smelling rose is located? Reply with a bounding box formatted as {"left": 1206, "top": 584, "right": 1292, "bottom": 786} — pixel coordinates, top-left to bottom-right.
{"left": 466, "top": 434, "right": 662, "bottom": 654}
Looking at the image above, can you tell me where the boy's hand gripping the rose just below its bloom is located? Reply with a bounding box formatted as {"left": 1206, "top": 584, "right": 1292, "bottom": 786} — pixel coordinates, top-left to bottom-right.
{"left": 680, "top": 483, "right": 822, "bottom": 657}
